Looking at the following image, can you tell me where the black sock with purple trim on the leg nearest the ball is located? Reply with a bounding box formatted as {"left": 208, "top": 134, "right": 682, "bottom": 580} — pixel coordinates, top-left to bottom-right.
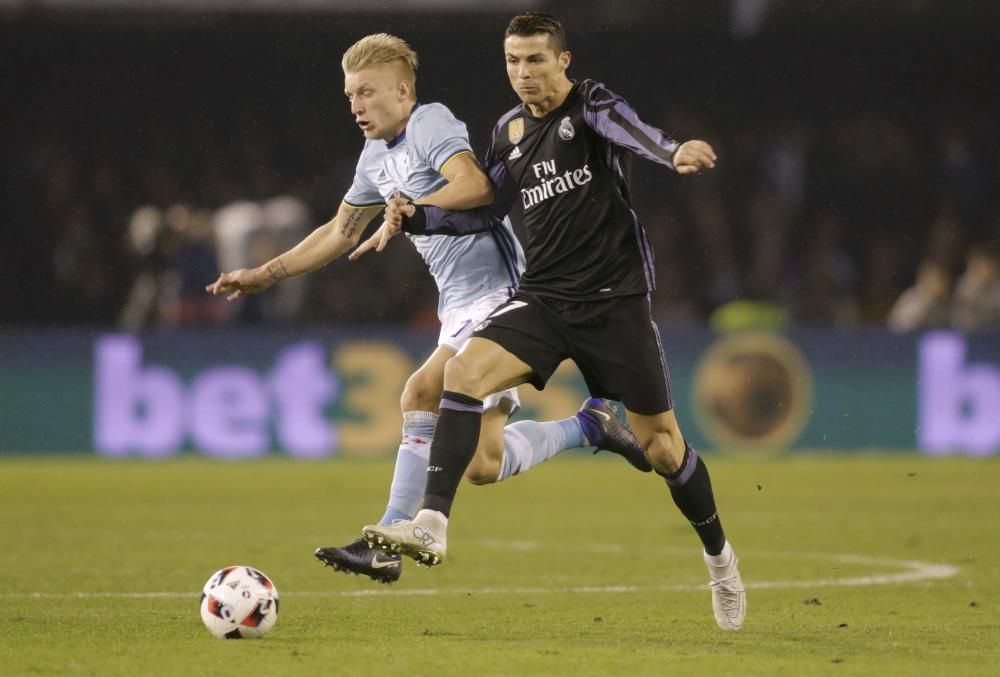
{"left": 423, "top": 390, "right": 483, "bottom": 517}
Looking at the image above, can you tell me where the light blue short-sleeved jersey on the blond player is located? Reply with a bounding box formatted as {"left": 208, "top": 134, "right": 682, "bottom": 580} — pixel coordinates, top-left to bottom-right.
{"left": 344, "top": 103, "right": 524, "bottom": 317}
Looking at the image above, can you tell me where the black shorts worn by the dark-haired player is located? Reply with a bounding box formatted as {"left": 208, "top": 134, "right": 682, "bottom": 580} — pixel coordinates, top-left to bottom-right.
{"left": 475, "top": 291, "right": 674, "bottom": 416}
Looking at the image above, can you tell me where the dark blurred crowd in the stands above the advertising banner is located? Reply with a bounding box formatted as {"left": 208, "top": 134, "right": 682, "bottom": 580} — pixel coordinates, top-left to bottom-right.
{"left": 0, "top": 2, "right": 1000, "bottom": 330}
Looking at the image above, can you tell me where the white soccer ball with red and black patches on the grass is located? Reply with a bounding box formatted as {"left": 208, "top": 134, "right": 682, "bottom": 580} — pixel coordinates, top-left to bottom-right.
{"left": 201, "top": 566, "right": 278, "bottom": 639}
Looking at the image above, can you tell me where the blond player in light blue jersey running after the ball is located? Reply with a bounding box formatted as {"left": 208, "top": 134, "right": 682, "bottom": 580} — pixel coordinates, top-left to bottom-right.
{"left": 207, "top": 33, "right": 649, "bottom": 583}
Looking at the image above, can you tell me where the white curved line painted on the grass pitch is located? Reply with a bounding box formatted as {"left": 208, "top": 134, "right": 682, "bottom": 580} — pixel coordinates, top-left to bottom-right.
{"left": 0, "top": 541, "right": 959, "bottom": 599}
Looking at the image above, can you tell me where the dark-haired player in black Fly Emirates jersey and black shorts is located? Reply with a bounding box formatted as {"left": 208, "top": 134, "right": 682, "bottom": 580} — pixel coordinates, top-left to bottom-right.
{"left": 364, "top": 12, "right": 746, "bottom": 630}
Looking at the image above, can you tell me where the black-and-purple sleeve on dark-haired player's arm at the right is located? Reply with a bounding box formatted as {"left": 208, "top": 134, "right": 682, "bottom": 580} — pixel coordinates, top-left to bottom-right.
{"left": 583, "top": 82, "right": 680, "bottom": 169}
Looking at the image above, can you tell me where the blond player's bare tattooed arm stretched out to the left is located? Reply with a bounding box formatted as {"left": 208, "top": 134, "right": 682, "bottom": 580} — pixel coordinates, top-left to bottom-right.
{"left": 205, "top": 202, "right": 383, "bottom": 301}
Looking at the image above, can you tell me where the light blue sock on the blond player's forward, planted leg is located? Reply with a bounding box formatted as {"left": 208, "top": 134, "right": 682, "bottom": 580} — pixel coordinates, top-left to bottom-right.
{"left": 379, "top": 411, "right": 437, "bottom": 524}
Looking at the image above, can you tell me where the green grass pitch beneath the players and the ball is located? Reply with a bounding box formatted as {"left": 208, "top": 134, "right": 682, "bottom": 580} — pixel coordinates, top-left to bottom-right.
{"left": 0, "top": 455, "right": 1000, "bottom": 677}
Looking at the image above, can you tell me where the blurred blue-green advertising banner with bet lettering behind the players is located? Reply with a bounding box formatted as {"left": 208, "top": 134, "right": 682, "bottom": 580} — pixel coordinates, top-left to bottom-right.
{"left": 0, "top": 326, "right": 1000, "bottom": 458}
